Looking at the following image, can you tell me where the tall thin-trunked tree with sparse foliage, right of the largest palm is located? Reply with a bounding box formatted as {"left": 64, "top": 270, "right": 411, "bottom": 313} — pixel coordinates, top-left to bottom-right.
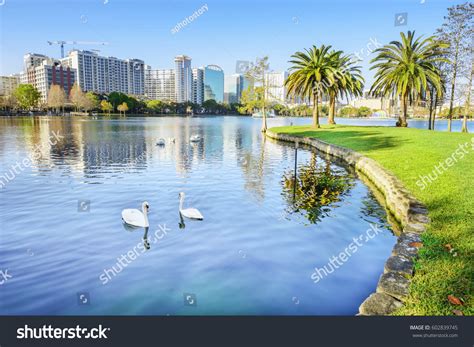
{"left": 437, "top": 2, "right": 474, "bottom": 131}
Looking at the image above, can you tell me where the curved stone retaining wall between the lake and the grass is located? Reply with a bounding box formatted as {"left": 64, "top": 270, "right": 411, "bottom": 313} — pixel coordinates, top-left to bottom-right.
{"left": 266, "top": 131, "right": 430, "bottom": 315}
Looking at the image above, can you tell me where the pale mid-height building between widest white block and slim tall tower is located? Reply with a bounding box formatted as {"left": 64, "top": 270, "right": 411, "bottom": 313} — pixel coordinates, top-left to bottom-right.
{"left": 145, "top": 65, "right": 176, "bottom": 101}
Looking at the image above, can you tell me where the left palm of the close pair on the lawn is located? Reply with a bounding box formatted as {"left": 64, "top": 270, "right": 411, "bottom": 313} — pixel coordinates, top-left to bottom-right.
{"left": 285, "top": 45, "right": 336, "bottom": 128}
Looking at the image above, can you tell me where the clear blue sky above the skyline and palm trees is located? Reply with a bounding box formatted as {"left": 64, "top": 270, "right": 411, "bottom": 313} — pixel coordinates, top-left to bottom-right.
{"left": 0, "top": 0, "right": 462, "bottom": 82}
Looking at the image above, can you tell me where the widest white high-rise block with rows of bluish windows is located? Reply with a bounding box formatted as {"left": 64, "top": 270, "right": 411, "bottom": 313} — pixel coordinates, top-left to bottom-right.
{"left": 61, "top": 50, "right": 145, "bottom": 96}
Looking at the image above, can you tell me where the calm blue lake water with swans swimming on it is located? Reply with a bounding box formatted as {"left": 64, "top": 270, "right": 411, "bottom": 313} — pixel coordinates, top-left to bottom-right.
{"left": 0, "top": 117, "right": 404, "bottom": 315}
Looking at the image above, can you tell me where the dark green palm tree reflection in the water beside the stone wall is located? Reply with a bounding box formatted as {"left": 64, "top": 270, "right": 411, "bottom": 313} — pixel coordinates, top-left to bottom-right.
{"left": 282, "top": 153, "right": 354, "bottom": 224}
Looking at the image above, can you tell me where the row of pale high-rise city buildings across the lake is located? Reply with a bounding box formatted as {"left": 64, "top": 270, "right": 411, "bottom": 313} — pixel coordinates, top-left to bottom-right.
{"left": 12, "top": 50, "right": 252, "bottom": 105}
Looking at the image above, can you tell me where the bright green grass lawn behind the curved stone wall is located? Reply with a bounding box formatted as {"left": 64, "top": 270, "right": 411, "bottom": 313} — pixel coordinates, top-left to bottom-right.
{"left": 271, "top": 125, "right": 474, "bottom": 315}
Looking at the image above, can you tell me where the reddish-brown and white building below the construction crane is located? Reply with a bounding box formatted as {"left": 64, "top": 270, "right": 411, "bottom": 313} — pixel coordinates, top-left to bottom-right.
{"left": 20, "top": 54, "right": 77, "bottom": 102}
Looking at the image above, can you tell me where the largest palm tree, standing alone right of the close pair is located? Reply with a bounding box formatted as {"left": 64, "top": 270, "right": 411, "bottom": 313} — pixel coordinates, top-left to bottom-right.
{"left": 370, "top": 31, "right": 448, "bottom": 127}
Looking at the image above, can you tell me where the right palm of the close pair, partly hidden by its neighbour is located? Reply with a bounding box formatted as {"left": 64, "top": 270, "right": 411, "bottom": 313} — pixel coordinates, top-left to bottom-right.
{"left": 328, "top": 51, "right": 364, "bottom": 124}
